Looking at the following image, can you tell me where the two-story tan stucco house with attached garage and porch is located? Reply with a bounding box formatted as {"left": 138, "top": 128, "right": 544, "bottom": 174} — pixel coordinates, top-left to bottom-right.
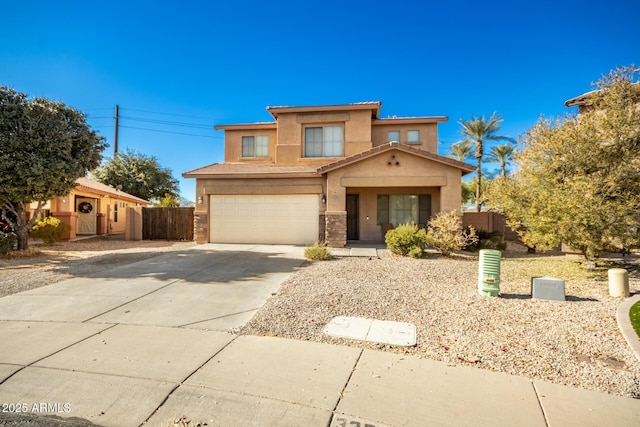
{"left": 183, "top": 102, "right": 475, "bottom": 247}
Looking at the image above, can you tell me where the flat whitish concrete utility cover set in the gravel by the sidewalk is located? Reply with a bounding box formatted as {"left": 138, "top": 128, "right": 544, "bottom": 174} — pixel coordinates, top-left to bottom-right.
{"left": 324, "top": 316, "right": 416, "bottom": 347}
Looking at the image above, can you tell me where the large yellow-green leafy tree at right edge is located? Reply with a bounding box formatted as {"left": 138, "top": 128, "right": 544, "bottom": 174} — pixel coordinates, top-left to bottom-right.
{"left": 489, "top": 67, "right": 640, "bottom": 259}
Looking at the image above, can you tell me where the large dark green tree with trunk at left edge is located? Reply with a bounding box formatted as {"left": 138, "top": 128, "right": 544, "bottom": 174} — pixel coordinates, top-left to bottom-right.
{"left": 0, "top": 86, "right": 106, "bottom": 249}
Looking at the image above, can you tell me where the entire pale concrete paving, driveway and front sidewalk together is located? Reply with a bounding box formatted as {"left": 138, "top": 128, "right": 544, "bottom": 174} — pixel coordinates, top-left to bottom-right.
{"left": 0, "top": 245, "right": 640, "bottom": 427}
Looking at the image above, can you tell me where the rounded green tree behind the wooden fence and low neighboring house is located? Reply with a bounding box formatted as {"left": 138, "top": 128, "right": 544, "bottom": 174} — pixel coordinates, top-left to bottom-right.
{"left": 92, "top": 150, "right": 179, "bottom": 201}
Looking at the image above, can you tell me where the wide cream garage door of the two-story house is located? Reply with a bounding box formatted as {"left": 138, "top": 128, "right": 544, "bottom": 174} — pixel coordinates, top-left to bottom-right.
{"left": 210, "top": 195, "right": 319, "bottom": 245}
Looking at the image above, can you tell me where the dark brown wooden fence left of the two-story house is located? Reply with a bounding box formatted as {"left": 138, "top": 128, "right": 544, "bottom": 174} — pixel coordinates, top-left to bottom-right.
{"left": 142, "top": 208, "right": 195, "bottom": 241}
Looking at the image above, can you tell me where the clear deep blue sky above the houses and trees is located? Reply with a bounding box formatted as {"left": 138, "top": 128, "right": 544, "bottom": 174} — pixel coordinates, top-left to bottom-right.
{"left": 0, "top": 0, "right": 640, "bottom": 200}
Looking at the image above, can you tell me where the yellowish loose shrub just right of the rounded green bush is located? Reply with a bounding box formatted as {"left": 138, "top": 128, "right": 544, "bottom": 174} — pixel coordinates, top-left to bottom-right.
{"left": 428, "top": 211, "right": 478, "bottom": 256}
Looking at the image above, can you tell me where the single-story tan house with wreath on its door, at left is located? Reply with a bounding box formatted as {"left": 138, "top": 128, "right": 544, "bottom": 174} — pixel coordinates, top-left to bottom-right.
{"left": 31, "top": 178, "right": 149, "bottom": 239}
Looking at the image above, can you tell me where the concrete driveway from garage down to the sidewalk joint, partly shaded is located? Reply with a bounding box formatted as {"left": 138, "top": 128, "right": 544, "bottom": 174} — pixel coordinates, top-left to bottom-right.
{"left": 0, "top": 244, "right": 304, "bottom": 331}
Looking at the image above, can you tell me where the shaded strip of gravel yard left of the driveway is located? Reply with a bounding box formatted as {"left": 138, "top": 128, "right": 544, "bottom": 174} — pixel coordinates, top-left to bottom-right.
{"left": 0, "top": 236, "right": 195, "bottom": 297}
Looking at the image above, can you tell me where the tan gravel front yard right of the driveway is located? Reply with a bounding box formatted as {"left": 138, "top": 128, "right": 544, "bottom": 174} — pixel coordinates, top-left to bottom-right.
{"left": 239, "top": 250, "right": 640, "bottom": 398}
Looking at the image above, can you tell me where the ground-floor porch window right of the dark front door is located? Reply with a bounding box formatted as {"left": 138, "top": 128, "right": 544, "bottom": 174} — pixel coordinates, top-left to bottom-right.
{"left": 377, "top": 194, "right": 431, "bottom": 227}
